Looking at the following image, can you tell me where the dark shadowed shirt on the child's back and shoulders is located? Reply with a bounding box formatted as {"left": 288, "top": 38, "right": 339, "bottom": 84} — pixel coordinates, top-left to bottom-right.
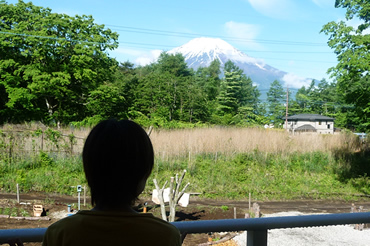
{"left": 42, "top": 211, "right": 181, "bottom": 246}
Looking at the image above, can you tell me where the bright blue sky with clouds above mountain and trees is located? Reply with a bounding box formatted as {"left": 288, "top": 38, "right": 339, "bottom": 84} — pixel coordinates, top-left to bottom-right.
{"left": 7, "top": 0, "right": 345, "bottom": 87}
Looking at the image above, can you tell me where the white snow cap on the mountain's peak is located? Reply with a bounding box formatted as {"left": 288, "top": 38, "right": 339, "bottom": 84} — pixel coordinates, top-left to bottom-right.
{"left": 168, "top": 37, "right": 264, "bottom": 68}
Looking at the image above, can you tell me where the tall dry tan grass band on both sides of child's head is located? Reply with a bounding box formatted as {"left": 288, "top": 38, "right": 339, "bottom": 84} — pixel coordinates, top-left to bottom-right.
{"left": 0, "top": 124, "right": 359, "bottom": 161}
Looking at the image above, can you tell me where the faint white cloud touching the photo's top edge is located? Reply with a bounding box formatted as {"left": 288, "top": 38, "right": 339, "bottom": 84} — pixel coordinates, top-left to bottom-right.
{"left": 248, "top": 0, "right": 296, "bottom": 19}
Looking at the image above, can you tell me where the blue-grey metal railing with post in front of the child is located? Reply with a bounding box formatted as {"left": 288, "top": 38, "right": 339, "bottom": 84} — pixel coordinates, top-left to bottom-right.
{"left": 0, "top": 212, "right": 370, "bottom": 246}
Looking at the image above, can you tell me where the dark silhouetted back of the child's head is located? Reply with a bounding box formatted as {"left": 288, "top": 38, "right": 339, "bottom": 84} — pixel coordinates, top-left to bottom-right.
{"left": 82, "top": 120, "right": 154, "bottom": 208}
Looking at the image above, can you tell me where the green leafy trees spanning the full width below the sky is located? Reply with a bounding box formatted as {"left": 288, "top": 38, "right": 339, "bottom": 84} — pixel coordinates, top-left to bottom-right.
{"left": 0, "top": 0, "right": 370, "bottom": 131}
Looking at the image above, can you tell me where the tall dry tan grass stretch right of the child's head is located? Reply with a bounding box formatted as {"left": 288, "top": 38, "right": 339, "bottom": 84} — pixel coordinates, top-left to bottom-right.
{"left": 150, "top": 128, "right": 358, "bottom": 158}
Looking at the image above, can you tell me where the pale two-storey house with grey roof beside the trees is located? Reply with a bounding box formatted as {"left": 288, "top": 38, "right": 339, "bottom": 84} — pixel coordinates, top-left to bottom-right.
{"left": 283, "top": 114, "right": 334, "bottom": 134}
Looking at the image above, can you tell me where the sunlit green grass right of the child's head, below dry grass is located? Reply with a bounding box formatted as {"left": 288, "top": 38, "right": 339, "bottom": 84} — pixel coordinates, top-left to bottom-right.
{"left": 149, "top": 151, "right": 370, "bottom": 200}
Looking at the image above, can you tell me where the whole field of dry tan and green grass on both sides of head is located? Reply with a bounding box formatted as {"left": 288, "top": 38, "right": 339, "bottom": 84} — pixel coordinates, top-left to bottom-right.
{"left": 0, "top": 124, "right": 370, "bottom": 200}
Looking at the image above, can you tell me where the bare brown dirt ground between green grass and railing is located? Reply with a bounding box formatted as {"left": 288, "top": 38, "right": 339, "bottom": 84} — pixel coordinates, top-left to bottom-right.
{"left": 0, "top": 194, "right": 370, "bottom": 246}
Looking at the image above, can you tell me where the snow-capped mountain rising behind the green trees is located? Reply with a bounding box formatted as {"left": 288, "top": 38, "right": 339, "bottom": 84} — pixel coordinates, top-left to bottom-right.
{"left": 168, "top": 37, "right": 288, "bottom": 90}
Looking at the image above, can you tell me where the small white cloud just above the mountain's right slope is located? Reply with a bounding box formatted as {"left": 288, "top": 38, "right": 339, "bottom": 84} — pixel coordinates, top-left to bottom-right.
{"left": 224, "top": 21, "right": 263, "bottom": 49}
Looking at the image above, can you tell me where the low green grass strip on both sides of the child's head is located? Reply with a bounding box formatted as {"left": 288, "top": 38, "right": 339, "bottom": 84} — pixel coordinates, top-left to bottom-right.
{"left": 0, "top": 147, "right": 370, "bottom": 201}
